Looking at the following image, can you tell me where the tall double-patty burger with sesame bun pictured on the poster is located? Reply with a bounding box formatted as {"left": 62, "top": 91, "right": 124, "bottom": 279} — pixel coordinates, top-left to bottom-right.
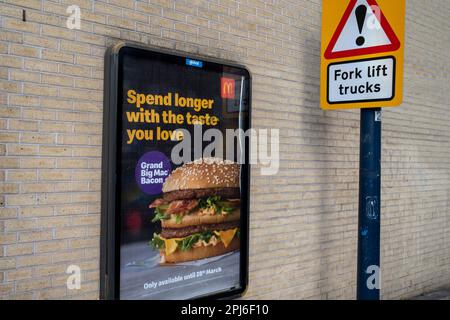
{"left": 150, "top": 158, "right": 240, "bottom": 263}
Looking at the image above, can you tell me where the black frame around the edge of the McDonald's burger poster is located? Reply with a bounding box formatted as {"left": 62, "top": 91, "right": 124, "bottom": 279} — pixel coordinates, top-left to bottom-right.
{"left": 100, "top": 42, "right": 252, "bottom": 299}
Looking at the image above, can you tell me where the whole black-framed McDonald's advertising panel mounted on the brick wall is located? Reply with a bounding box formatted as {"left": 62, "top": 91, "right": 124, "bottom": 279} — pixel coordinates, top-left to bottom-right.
{"left": 101, "top": 43, "right": 250, "bottom": 299}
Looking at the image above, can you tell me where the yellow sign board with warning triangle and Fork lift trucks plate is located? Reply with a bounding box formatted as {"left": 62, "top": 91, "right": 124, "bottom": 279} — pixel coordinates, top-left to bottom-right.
{"left": 320, "top": 0, "right": 405, "bottom": 110}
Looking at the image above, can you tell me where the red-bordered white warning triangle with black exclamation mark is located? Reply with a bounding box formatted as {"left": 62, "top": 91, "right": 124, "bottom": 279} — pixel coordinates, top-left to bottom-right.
{"left": 324, "top": 0, "right": 400, "bottom": 59}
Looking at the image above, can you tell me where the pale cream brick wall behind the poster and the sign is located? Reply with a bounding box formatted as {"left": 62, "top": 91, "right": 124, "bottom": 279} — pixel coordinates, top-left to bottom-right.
{"left": 0, "top": 0, "right": 450, "bottom": 299}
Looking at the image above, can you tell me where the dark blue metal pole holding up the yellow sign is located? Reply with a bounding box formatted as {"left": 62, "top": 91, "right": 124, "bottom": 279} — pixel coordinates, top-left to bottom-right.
{"left": 356, "top": 108, "right": 381, "bottom": 300}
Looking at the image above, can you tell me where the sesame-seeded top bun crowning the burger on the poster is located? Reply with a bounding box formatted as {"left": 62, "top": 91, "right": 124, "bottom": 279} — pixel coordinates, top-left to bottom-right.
{"left": 162, "top": 158, "right": 239, "bottom": 193}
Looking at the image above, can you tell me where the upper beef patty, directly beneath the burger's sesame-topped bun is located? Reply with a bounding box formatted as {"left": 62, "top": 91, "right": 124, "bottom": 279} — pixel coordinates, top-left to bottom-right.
{"left": 163, "top": 188, "right": 241, "bottom": 202}
